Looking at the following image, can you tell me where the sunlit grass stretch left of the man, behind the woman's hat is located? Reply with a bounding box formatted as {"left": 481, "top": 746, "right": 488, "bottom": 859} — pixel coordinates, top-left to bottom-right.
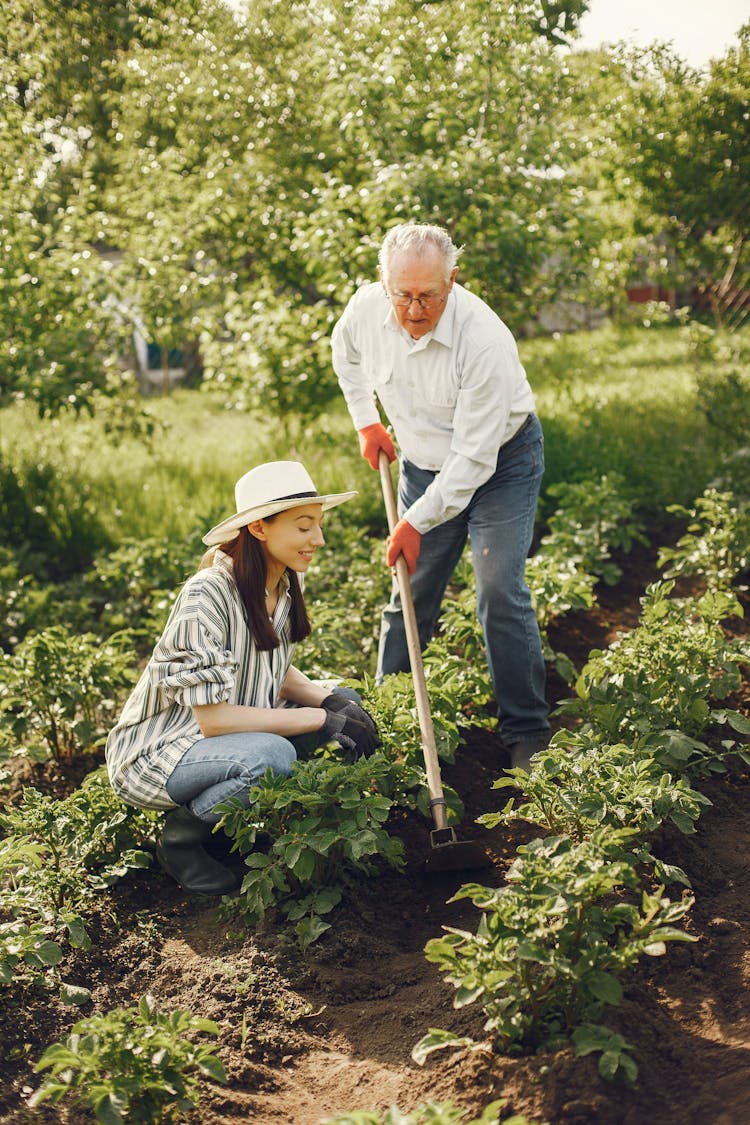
{"left": 0, "top": 390, "right": 380, "bottom": 561}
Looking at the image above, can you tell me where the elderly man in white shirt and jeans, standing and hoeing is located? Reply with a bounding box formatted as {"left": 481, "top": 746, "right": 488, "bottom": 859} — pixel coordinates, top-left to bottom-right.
{"left": 332, "top": 223, "right": 550, "bottom": 768}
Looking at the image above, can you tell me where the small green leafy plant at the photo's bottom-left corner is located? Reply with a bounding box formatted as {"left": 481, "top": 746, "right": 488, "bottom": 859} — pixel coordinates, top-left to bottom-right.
{"left": 29, "top": 996, "right": 227, "bottom": 1125}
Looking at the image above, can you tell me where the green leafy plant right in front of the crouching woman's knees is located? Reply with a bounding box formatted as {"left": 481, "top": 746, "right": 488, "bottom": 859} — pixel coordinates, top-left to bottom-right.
{"left": 220, "top": 754, "right": 413, "bottom": 948}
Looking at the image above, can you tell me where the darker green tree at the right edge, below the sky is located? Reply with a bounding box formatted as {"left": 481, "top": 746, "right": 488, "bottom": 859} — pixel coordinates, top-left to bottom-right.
{"left": 621, "top": 24, "right": 750, "bottom": 327}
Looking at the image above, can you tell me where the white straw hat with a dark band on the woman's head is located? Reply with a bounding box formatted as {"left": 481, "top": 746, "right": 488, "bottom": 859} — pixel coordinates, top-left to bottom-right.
{"left": 204, "top": 461, "right": 356, "bottom": 547}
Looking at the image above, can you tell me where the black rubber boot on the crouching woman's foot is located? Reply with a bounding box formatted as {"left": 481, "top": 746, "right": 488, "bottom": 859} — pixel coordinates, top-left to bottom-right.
{"left": 156, "top": 804, "right": 238, "bottom": 894}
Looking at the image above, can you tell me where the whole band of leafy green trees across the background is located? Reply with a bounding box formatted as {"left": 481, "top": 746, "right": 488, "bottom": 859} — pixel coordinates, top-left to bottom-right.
{"left": 0, "top": 0, "right": 749, "bottom": 425}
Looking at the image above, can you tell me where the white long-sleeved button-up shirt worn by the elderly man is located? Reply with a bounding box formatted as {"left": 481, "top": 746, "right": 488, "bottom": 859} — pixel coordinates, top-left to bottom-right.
{"left": 332, "top": 281, "right": 534, "bottom": 532}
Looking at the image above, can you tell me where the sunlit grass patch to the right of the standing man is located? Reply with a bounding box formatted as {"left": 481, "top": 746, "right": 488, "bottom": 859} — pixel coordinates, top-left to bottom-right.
{"left": 522, "top": 325, "right": 737, "bottom": 511}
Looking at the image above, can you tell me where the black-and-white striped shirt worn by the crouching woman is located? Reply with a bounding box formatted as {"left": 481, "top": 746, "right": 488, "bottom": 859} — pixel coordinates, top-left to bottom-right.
{"left": 106, "top": 551, "right": 295, "bottom": 809}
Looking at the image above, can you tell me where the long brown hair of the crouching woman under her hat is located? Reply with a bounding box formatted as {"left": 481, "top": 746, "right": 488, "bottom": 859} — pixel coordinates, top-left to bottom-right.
{"left": 201, "top": 515, "right": 310, "bottom": 651}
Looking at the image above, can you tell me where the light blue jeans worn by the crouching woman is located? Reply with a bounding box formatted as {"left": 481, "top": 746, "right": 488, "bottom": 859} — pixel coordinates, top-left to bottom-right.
{"left": 166, "top": 687, "right": 360, "bottom": 825}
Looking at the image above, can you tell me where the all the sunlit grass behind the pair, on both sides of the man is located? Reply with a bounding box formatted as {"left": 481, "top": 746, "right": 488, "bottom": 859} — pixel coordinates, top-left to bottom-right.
{"left": 0, "top": 324, "right": 750, "bottom": 572}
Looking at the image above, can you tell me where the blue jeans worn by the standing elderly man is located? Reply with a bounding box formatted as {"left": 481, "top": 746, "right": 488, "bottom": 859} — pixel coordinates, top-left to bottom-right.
{"left": 377, "top": 414, "right": 550, "bottom": 746}
